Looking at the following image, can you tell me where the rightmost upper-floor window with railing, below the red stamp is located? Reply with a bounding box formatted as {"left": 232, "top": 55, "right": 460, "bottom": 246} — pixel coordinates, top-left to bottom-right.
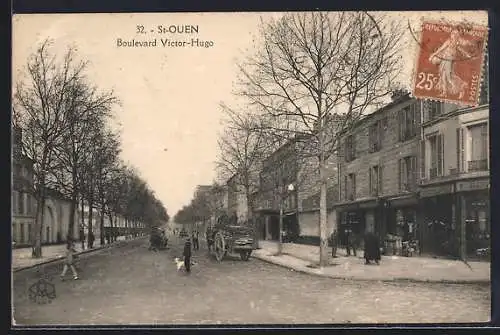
{"left": 468, "top": 122, "right": 489, "bottom": 171}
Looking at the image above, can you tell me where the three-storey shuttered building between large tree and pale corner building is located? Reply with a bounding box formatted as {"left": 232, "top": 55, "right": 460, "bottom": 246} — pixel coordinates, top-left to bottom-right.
{"left": 335, "top": 92, "right": 422, "bottom": 244}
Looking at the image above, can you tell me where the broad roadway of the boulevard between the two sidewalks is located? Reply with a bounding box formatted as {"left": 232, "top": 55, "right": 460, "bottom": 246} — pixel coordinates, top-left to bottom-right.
{"left": 13, "top": 238, "right": 490, "bottom": 325}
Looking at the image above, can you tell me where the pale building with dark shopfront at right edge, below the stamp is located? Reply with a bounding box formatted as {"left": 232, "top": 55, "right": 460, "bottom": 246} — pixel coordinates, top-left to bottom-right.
{"left": 420, "top": 100, "right": 490, "bottom": 259}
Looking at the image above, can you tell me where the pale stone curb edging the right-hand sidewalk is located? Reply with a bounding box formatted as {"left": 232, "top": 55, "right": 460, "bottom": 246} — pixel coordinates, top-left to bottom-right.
{"left": 251, "top": 255, "right": 491, "bottom": 285}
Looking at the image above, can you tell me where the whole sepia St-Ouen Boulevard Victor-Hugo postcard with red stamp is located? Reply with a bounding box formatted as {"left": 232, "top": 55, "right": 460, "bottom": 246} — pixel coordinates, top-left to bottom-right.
{"left": 11, "top": 11, "right": 491, "bottom": 327}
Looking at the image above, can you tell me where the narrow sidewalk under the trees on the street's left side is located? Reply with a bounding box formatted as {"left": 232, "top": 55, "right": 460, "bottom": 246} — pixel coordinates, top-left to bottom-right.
{"left": 12, "top": 236, "right": 141, "bottom": 271}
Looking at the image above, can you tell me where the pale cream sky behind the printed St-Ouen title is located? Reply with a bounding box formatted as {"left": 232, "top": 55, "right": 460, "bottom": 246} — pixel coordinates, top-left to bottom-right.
{"left": 12, "top": 11, "right": 487, "bottom": 216}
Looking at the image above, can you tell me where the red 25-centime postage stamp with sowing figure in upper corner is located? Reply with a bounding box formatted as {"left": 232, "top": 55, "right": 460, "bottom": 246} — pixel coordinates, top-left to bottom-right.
{"left": 413, "top": 22, "right": 488, "bottom": 106}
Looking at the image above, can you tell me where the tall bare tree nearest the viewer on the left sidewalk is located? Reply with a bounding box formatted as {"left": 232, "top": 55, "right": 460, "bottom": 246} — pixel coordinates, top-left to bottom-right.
{"left": 13, "top": 40, "right": 89, "bottom": 258}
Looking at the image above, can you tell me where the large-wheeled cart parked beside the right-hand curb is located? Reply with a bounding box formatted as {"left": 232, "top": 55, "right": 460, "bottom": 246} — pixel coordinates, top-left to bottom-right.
{"left": 212, "top": 220, "right": 254, "bottom": 262}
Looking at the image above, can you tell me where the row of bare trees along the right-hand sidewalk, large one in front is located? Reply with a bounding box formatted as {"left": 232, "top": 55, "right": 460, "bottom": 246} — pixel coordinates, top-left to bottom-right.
{"left": 218, "top": 12, "right": 404, "bottom": 266}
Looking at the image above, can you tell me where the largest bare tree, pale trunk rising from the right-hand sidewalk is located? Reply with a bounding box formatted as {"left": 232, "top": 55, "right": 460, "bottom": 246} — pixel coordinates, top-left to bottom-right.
{"left": 237, "top": 12, "right": 403, "bottom": 266}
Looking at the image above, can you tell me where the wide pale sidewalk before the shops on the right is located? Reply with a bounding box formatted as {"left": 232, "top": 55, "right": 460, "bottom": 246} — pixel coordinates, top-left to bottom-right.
{"left": 252, "top": 241, "right": 491, "bottom": 283}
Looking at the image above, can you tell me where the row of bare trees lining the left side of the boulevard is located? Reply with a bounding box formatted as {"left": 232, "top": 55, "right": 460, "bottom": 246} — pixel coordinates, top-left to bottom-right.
{"left": 12, "top": 40, "right": 168, "bottom": 258}
